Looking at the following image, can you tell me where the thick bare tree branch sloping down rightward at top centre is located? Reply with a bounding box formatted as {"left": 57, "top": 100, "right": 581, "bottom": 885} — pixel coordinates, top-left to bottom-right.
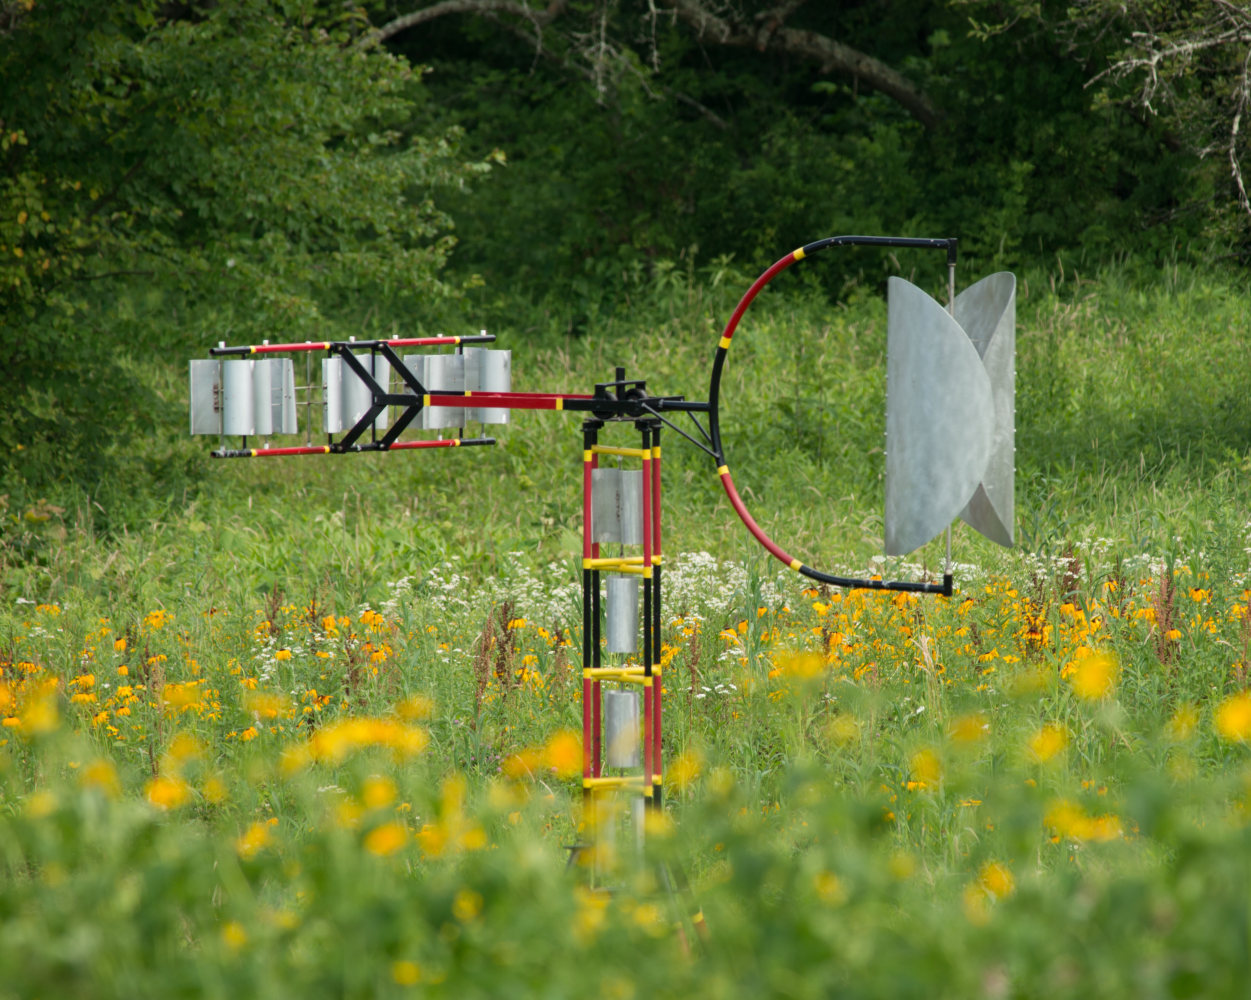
{"left": 664, "top": 0, "right": 942, "bottom": 129}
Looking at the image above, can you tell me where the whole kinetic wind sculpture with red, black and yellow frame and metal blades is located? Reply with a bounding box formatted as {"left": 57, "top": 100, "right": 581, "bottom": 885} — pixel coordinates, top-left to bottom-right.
{"left": 190, "top": 237, "right": 1016, "bottom": 851}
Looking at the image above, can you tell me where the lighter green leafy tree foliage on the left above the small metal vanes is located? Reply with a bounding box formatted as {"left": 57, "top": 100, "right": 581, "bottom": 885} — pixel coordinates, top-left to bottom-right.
{"left": 0, "top": 0, "right": 497, "bottom": 513}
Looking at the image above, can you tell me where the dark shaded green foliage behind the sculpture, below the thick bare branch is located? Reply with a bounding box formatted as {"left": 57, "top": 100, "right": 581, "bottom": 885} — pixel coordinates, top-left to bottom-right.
{"left": 393, "top": 3, "right": 1210, "bottom": 320}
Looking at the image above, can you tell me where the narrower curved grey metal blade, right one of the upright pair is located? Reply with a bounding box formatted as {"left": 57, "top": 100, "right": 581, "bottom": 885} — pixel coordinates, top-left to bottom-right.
{"left": 955, "top": 270, "right": 1016, "bottom": 547}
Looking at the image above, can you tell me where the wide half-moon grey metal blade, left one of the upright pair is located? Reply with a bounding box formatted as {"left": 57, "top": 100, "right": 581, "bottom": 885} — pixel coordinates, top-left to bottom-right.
{"left": 886, "top": 278, "right": 995, "bottom": 556}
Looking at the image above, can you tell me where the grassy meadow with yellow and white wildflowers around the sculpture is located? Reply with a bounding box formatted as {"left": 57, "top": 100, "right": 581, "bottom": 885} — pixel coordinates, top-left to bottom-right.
{"left": 0, "top": 262, "right": 1251, "bottom": 1000}
